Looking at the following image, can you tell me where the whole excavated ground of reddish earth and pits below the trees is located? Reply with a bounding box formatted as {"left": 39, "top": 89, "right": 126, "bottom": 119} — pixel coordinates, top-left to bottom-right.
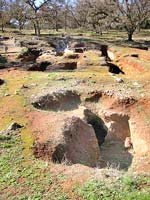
{"left": 0, "top": 28, "right": 150, "bottom": 200}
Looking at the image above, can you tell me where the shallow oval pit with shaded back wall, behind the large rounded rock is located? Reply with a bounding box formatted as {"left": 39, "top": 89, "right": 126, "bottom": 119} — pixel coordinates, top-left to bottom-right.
{"left": 32, "top": 90, "right": 81, "bottom": 111}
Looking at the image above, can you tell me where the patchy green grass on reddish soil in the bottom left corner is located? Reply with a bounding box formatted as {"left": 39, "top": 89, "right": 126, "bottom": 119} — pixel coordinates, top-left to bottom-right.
{"left": 0, "top": 130, "right": 69, "bottom": 200}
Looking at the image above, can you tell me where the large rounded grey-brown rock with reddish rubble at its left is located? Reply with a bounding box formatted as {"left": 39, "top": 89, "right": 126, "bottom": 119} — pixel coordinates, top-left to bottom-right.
{"left": 34, "top": 117, "right": 100, "bottom": 167}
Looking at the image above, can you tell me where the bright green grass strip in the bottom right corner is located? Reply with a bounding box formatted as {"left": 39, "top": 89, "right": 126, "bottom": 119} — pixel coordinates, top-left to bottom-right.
{"left": 78, "top": 175, "right": 150, "bottom": 200}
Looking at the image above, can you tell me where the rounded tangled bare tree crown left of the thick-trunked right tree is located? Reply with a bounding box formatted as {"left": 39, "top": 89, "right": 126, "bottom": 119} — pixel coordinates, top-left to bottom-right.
{"left": 76, "top": 0, "right": 116, "bottom": 34}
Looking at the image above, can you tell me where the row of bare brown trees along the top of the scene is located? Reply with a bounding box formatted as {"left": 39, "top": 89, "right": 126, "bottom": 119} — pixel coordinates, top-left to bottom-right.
{"left": 0, "top": 0, "right": 150, "bottom": 41}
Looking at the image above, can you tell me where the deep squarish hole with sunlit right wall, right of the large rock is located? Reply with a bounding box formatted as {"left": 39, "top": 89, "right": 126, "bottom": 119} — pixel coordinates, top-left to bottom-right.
{"left": 101, "top": 112, "right": 133, "bottom": 170}
